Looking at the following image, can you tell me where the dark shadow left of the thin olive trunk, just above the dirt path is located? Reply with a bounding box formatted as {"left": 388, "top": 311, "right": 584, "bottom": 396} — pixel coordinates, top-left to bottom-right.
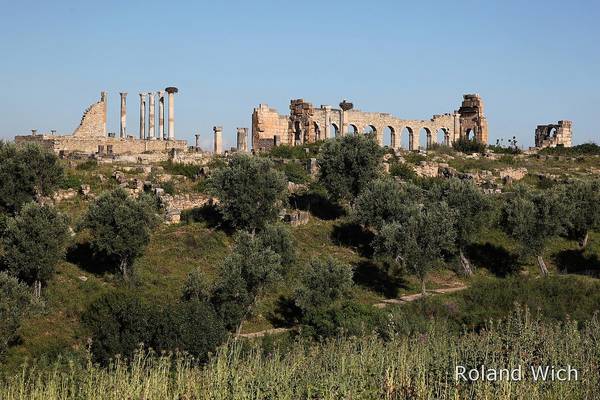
{"left": 354, "top": 261, "right": 408, "bottom": 298}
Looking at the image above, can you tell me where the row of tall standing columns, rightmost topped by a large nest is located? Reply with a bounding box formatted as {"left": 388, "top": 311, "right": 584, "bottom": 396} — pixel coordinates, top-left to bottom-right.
{"left": 119, "top": 87, "right": 179, "bottom": 140}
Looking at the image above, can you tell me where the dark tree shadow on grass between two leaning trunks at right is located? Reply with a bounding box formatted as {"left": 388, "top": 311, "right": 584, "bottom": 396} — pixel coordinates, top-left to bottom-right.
{"left": 466, "top": 243, "right": 521, "bottom": 277}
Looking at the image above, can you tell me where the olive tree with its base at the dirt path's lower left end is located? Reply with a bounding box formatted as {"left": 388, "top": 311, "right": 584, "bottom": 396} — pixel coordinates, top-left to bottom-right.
{"left": 211, "top": 232, "right": 282, "bottom": 333}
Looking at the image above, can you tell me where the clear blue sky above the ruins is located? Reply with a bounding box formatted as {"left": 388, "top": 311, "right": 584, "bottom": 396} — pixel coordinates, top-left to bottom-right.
{"left": 0, "top": 0, "right": 600, "bottom": 148}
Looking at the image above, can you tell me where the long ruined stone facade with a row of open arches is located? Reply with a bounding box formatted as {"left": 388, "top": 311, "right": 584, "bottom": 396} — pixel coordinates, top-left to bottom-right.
{"left": 252, "top": 94, "right": 488, "bottom": 151}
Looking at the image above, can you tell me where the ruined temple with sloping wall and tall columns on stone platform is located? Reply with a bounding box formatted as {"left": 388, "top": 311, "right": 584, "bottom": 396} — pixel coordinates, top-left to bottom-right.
{"left": 15, "top": 87, "right": 187, "bottom": 155}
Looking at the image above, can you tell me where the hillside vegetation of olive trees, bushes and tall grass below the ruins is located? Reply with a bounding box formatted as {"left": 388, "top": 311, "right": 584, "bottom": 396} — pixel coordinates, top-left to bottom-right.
{"left": 0, "top": 135, "right": 600, "bottom": 399}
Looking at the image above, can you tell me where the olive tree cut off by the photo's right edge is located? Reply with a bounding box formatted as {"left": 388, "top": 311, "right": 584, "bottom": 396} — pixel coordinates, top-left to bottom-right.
{"left": 561, "top": 179, "right": 600, "bottom": 249}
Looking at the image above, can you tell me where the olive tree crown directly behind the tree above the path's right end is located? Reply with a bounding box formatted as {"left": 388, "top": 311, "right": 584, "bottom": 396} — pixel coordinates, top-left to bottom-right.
{"left": 352, "top": 177, "right": 423, "bottom": 231}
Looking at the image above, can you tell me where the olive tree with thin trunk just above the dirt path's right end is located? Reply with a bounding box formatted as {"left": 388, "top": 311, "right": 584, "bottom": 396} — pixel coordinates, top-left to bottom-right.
{"left": 373, "top": 202, "right": 456, "bottom": 295}
